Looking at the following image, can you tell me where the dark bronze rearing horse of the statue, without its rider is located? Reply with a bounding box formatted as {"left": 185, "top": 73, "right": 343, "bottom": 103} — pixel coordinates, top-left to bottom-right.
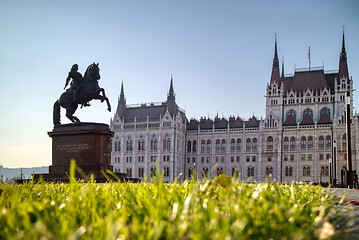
{"left": 53, "top": 63, "right": 111, "bottom": 126}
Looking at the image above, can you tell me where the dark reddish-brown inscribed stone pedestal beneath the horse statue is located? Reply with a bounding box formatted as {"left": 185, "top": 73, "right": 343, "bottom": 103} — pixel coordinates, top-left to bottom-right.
{"left": 48, "top": 123, "right": 113, "bottom": 175}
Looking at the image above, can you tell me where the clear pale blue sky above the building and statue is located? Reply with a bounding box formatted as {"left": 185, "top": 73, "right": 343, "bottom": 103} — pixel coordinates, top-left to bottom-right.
{"left": 0, "top": 0, "right": 359, "bottom": 167}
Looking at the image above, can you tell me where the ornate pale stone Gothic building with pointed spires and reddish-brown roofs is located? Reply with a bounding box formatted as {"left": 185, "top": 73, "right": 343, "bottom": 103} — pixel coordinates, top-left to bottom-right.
{"left": 110, "top": 33, "right": 359, "bottom": 183}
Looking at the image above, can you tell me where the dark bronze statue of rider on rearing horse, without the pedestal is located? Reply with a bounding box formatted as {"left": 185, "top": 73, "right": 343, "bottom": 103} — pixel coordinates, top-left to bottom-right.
{"left": 53, "top": 63, "right": 111, "bottom": 126}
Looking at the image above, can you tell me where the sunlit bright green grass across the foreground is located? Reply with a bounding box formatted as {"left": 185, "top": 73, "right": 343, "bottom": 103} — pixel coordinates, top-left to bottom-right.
{"left": 0, "top": 175, "right": 348, "bottom": 239}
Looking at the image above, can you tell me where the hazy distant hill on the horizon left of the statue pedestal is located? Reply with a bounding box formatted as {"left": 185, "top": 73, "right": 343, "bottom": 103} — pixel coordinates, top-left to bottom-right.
{"left": 0, "top": 166, "right": 49, "bottom": 181}
